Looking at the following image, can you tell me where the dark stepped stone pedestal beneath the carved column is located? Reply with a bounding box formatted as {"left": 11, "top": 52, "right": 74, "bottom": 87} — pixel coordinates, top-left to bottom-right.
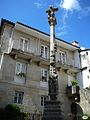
{"left": 42, "top": 100, "right": 64, "bottom": 120}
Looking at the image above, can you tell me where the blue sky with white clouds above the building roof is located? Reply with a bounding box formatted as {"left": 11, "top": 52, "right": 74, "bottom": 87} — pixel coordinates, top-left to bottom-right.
{"left": 0, "top": 0, "right": 90, "bottom": 49}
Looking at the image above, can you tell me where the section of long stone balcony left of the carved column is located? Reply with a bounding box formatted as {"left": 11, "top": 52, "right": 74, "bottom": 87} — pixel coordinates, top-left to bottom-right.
{"left": 10, "top": 48, "right": 49, "bottom": 66}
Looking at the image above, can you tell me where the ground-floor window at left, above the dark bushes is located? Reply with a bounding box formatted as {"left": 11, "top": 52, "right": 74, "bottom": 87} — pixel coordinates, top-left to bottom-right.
{"left": 14, "top": 91, "right": 24, "bottom": 104}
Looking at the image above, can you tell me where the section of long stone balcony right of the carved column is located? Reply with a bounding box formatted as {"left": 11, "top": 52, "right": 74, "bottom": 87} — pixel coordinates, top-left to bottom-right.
{"left": 56, "top": 60, "right": 80, "bottom": 73}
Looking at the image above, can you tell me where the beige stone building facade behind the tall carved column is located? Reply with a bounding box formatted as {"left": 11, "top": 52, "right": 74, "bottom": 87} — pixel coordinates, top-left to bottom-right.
{"left": 0, "top": 19, "right": 82, "bottom": 116}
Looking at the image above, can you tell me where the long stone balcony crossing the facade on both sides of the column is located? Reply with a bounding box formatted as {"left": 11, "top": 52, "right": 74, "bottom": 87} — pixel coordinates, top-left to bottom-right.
{"left": 10, "top": 48, "right": 80, "bottom": 73}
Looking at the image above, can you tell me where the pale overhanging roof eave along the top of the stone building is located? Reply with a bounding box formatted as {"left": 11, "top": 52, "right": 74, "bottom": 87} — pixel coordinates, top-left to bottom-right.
{"left": 15, "top": 22, "right": 80, "bottom": 51}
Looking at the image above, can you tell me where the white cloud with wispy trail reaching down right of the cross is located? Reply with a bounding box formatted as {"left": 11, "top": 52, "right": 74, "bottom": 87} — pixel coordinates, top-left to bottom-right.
{"left": 57, "top": 0, "right": 82, "bottom": 36}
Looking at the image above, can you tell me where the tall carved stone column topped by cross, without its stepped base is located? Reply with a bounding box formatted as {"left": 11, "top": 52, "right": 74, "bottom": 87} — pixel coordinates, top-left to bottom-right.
{"left": 46, "top": 6, "right": 58, "bottom": 100}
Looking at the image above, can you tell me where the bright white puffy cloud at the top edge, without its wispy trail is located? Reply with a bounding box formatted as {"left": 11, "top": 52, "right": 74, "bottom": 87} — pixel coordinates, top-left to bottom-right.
{"left": 60, "top": 0, "right": 81, "bottom": 11}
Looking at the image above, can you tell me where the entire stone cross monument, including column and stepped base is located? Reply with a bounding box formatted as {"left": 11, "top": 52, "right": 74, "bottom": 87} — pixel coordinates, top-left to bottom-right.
{"left": 42, "top": 6, "right": 64, "bottom": 120}
